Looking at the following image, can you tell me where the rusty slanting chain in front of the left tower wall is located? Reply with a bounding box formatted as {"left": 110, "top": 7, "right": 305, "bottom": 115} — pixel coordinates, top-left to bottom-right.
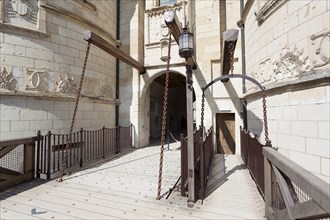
{"left": 58, "top": 42, "right": 91, "bottom": 182}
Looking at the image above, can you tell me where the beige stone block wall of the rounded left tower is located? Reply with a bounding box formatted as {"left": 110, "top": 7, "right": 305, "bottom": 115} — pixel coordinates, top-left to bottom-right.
{"left": 0, "top": 0, "right": 116, "bottom": 139}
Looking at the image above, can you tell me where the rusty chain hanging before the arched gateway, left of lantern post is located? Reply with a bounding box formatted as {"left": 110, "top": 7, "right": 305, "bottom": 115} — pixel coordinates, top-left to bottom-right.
{"left": 157, "top": 29, "right": 171, "bottom": 200}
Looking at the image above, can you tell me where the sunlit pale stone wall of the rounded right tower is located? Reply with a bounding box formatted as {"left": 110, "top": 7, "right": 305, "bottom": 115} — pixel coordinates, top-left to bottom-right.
{"left": 245, "top": 0, "right": 330, "bottom": 181}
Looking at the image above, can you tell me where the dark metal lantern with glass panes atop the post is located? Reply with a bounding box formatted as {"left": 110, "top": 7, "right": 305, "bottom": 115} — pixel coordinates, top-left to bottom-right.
{"left": 179, "top": 27, "right": 194, "bottom": 59}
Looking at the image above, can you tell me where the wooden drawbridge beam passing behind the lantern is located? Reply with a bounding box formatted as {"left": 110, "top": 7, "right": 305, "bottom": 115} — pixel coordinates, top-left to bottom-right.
{"left": 164, "top": 10, "right": 197, "bottom": 69}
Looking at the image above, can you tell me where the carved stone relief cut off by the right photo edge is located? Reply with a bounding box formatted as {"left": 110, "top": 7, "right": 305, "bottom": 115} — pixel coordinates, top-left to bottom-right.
{"left": 310, "top": 31, "right": 330, "bottom": 68}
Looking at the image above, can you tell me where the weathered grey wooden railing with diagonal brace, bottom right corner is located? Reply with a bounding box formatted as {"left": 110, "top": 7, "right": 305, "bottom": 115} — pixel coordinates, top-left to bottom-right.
{"left": 263, "top": 147, "right": 330, "bottom": 219}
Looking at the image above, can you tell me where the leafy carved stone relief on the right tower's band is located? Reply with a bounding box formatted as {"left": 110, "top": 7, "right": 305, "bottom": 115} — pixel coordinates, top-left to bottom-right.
{"left": 273, "top": 47, "right": 311, "bottom": 80}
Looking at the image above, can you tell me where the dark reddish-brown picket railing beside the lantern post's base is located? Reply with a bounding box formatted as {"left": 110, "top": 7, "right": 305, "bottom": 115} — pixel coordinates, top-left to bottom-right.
{"left": 180, "top": 127, "right": 213, "bottom": 199}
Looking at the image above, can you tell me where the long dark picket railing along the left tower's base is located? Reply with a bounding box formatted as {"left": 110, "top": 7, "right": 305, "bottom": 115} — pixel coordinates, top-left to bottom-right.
{"left": 36, "top": 125, "right": 133, "bottom": 179}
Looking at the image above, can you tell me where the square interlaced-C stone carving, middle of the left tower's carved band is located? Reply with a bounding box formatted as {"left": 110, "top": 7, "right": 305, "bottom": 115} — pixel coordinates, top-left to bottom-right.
{"left": 25, "top": 68, "right": 48, "bottom": 92}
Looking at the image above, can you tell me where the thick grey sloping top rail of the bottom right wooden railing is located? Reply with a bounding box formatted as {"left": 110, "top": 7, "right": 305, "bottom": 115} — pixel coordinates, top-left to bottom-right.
{"left": 263, "top": 147, "right": 330, "bottom": 213}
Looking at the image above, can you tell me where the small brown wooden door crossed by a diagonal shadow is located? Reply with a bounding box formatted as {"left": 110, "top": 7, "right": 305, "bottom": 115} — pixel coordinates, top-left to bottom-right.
{"left": 216, "top": 113, "right": 235, "bottom": 154}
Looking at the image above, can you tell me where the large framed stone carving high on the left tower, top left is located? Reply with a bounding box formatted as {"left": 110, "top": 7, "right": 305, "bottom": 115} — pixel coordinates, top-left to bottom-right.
{"left": 4, "top": 0, "right": 38, "bottom": 29}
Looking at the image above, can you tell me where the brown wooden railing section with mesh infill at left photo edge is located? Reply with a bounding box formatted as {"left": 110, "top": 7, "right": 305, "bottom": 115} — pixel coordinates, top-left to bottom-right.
{"left": 0, "top": 137, "right": 36, "bottom": 190}
